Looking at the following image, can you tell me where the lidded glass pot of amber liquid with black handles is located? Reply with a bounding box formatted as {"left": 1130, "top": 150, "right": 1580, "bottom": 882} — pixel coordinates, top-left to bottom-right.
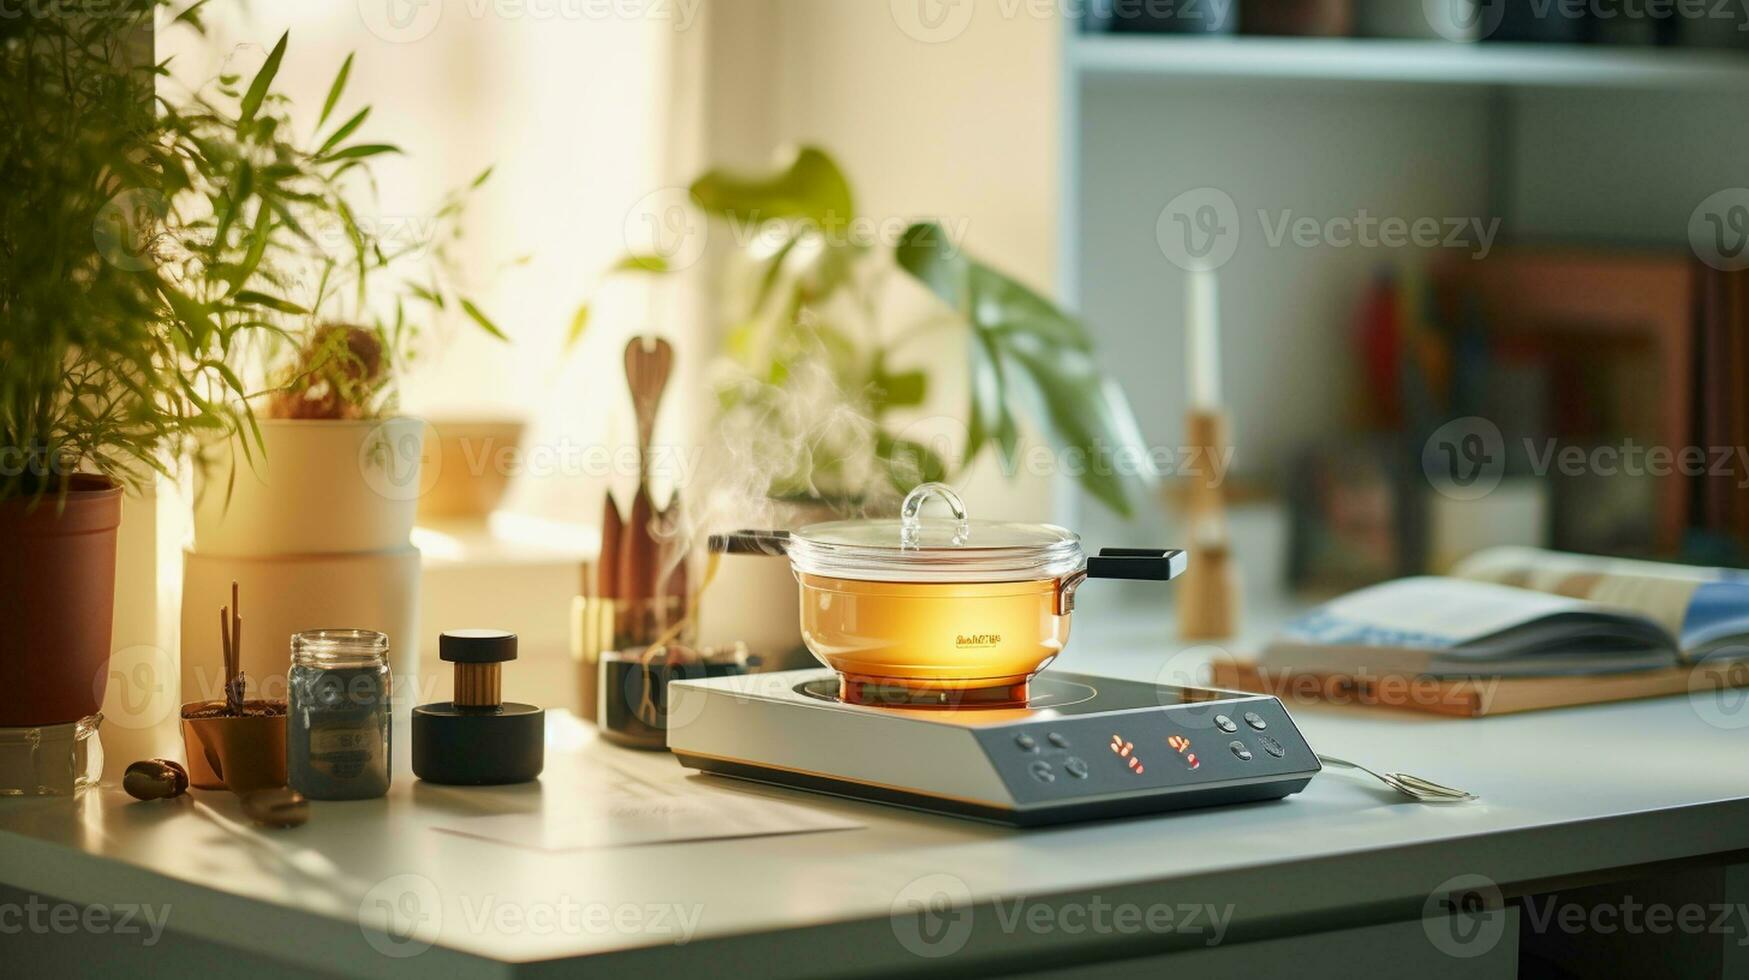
{"left": 731, "top": 483, "right": 1184, "bottom": 707}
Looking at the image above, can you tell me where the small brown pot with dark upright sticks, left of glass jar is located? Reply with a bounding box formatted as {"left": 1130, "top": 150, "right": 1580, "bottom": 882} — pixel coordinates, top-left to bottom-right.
{"left": 182, "top": 583, "right": 285, "bottom": 793}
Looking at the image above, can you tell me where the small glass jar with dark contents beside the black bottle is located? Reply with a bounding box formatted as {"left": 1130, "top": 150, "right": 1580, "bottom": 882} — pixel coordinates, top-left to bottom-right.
{"left": 285, "top": 630, "right": 392, "bottom": 800}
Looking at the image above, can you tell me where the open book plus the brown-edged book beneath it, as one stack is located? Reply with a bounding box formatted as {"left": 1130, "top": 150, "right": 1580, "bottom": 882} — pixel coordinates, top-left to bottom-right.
{"left": 1214, "top": 548, "right": 1749, "bottom": 716}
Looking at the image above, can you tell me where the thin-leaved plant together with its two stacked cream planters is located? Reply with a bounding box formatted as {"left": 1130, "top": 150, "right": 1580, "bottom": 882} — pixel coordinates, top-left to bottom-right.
{"left": 153, "top": 35, "right": 504, "bottom": 698}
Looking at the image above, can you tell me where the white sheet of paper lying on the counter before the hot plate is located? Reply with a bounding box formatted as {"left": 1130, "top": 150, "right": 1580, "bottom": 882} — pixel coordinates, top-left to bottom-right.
{"left": 425, "top": 767, "right": 862, "bottom": 851}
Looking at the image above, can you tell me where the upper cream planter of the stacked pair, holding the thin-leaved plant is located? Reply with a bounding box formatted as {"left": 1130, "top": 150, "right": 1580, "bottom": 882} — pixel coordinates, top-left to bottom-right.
{"left": 194, "top": 417, "right": 427, "bottom": 560}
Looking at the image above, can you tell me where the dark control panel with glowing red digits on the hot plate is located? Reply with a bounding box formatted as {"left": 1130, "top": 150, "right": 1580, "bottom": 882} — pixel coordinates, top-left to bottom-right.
{"left": 978, "top": 698, "right": 1319, "bottom": 803}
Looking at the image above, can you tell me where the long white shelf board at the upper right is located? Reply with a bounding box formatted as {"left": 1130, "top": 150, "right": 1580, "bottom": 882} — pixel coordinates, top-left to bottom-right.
{"left": 1069, "top": 35, "right": 1749, "bottom": 91}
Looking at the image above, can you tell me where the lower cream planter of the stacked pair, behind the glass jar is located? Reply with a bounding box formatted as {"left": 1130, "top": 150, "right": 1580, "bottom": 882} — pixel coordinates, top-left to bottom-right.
{"left": 182, "top": 548, "right": 430, "bottom": 711}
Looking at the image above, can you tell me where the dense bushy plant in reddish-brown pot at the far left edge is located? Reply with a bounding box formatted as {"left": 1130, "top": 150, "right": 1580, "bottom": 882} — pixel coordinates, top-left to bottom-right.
{"left": 0, "top": 4, "right": 252, "bottom": 728}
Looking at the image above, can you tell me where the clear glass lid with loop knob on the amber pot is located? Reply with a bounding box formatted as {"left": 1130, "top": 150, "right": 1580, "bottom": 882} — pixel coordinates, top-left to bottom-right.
{"left": 789, "top": 483, "right": 1083, "bottom": 583}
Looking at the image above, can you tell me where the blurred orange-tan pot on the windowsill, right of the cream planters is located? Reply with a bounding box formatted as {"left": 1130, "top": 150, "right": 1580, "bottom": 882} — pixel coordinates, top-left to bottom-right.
{"left": 418, "top": 418, "right": 523, "bottom": 522}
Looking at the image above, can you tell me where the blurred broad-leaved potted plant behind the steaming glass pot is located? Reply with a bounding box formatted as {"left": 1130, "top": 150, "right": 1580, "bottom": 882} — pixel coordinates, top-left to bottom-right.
{"left": 572, "top": 147, "right": 1154, "bottom": 665}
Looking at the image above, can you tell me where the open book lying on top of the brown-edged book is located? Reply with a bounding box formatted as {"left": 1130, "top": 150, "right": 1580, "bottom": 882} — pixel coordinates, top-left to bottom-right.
{"left": 1258, "top": 548, "right": 1749, "bottom": 677}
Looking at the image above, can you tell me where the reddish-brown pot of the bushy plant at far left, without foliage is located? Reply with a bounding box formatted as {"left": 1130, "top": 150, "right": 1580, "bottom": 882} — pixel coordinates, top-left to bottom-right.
{"left": 0, "top": 474, "right": 121, "bottom": 728}
